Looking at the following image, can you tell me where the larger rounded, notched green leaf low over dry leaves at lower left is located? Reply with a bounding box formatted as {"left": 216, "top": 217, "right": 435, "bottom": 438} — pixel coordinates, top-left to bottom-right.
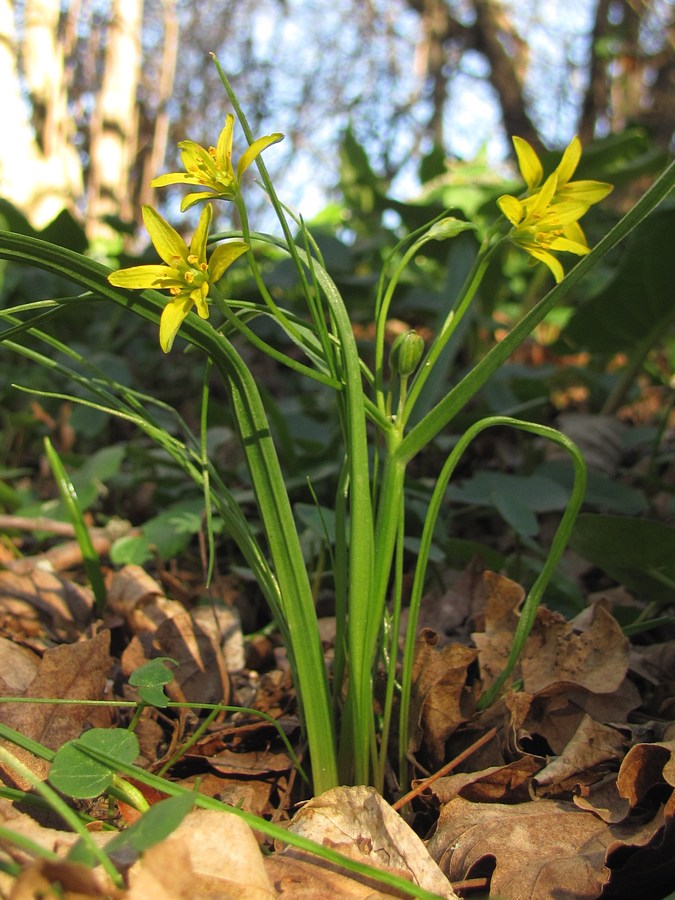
{"left": 49, "top": 728, "right": 139, "bottom": 800}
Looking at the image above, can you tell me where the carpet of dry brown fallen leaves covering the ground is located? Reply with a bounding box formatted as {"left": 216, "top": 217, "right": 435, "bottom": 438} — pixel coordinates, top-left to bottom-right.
{"left": 0, "top": 528, "right": 675, "bottom": 900}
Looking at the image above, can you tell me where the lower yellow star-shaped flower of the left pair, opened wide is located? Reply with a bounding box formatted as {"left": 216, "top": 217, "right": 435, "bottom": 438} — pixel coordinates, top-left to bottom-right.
{"left": 108, "top": 203, "right": 248, "bottom": 353}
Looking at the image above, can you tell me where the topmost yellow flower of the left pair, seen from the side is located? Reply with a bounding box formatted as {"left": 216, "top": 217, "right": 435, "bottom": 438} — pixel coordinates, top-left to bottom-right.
{"left": 150, "top": 113, "right": 284, "bottom": 212}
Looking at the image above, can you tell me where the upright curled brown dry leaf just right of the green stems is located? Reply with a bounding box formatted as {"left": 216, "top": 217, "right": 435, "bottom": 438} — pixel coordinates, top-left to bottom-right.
{"left": 410, "top": 628, "right": 476, "bottom": 766}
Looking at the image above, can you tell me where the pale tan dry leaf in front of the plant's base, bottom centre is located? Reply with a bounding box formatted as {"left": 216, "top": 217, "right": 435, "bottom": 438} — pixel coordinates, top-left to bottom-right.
{"left": 282, "top": 787, "right": 456, "bottom": 898}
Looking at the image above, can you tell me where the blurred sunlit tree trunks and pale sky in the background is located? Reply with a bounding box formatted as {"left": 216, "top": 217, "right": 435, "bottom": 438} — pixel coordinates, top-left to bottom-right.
{"left": 0, "top": 0, "right": 675, "bottom": 240}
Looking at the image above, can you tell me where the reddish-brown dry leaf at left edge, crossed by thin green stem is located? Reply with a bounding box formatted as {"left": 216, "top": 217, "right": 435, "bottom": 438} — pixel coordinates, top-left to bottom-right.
{"left": 0, "top": 631, "right": 110, "bottom": 789}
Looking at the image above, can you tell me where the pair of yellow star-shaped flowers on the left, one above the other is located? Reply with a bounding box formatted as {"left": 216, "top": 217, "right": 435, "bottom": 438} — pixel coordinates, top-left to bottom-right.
{"left": 108, "top": 114, "right": 283, "bottom": 353}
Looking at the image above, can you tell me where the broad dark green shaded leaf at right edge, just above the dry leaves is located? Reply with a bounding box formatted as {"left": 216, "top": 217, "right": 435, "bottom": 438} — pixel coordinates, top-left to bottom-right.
{"left": 570, "top": 513, "right": 675, "bottom": 603}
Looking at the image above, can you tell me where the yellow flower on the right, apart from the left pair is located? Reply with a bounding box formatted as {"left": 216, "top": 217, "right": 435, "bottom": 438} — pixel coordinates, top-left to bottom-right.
{"left": 497, "top": 137, "right": 612, "bottom": 282}
